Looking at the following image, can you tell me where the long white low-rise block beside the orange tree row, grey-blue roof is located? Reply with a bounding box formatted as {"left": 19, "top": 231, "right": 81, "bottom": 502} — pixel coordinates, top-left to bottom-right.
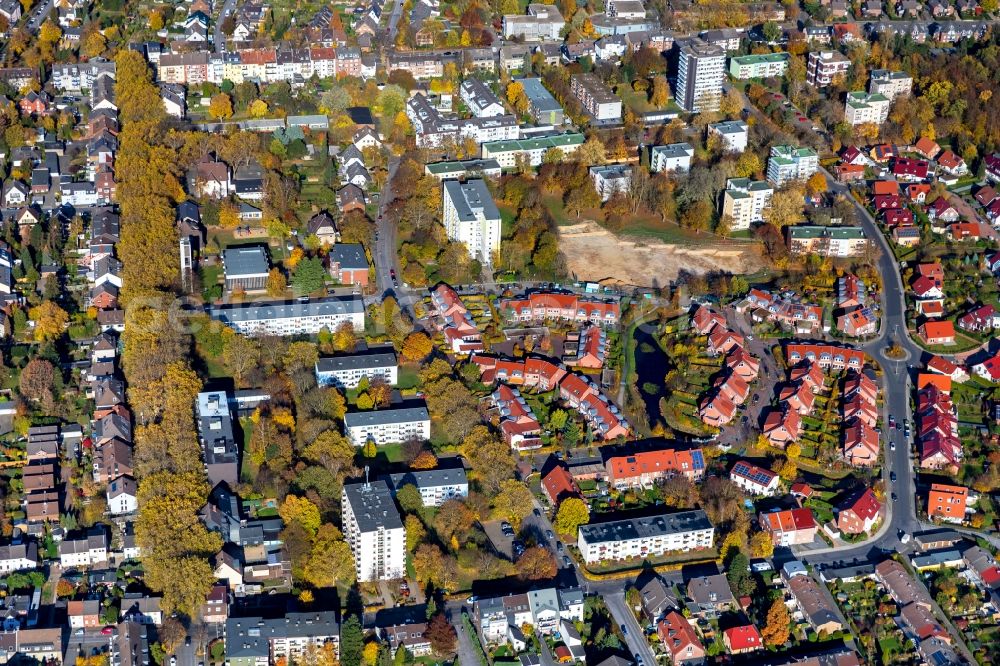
{"left": 208, "top": 296, "right": 365, "bottom": 337}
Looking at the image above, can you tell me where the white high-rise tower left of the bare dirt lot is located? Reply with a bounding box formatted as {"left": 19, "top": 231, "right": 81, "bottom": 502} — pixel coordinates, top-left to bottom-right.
{"left": 441, "top": 179, "right": 500, "bottom": 265}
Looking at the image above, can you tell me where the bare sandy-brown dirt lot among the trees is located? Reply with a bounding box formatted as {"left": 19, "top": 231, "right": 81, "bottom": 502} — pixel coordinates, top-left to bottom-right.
{"left": 559, "top": 222, "right": 764, "bottom": 287}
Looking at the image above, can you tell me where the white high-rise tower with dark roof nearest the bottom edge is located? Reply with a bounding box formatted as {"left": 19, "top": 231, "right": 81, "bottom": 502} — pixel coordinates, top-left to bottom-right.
{"left": 341, "top": 480, "right": 406, "bottom": 582}
